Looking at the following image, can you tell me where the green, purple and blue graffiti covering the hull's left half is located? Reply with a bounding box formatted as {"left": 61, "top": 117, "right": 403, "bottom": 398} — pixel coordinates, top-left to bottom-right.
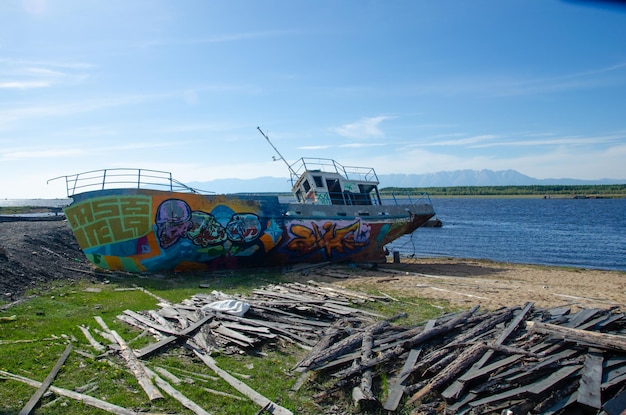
{"left": 66, "top": 195, "right": 283, "bottom": 272}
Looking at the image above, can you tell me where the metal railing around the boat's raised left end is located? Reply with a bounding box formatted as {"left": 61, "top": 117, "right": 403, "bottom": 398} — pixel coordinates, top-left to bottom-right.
{"left": 48, "top": 168, "right": 211, "bottom": 197}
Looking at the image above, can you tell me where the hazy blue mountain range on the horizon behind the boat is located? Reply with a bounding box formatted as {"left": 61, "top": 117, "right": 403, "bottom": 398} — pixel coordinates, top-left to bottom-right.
{"left": 187, "top": 170, "right": 626, "bottom": 193}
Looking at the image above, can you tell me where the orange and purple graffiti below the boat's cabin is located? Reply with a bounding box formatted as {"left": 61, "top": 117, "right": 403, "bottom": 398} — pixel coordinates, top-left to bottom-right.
{"left": 285, "top": 219, "right": 370, "bottom": 259}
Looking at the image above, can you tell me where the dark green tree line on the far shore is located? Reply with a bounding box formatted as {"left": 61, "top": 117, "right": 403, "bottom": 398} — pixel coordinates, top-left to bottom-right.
{"left": 380, "top": 184, "right": 626, "bottom": 197}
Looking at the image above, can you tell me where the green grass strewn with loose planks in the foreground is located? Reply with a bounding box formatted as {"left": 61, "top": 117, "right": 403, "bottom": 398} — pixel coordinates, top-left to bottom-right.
{"left": 0, "top": 271, "right": 448, "bottom": 415}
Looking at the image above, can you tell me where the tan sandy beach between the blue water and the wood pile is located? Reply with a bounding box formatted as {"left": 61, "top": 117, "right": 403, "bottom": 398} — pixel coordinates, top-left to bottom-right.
{"left": 339, "top": 258, "right": 626, "bottom": 309}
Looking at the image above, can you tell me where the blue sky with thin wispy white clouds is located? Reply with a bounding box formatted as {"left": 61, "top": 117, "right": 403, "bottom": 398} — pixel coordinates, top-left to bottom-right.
{"left": 0, "top": 0, "right": 626, "bottom": 198}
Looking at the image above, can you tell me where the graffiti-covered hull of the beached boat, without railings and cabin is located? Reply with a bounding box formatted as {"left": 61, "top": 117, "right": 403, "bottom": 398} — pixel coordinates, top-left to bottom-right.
{"left": 65, "top": 189, "right": 434, "bottom": 272}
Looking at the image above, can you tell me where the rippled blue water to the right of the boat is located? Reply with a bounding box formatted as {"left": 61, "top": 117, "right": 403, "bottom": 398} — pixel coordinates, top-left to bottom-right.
{"left": 388, "top": 198, "right": 626, "bottom": 271}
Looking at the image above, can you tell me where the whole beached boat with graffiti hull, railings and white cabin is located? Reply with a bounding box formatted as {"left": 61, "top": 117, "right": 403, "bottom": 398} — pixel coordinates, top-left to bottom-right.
{"left": 52, "top": 133, "right": 435, "bottom": 272}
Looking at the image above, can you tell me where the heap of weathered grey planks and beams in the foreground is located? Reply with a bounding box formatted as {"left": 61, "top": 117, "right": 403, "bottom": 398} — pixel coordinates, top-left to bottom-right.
{"left": 107, "top": 282, "right": 626, "bottom": 415}
